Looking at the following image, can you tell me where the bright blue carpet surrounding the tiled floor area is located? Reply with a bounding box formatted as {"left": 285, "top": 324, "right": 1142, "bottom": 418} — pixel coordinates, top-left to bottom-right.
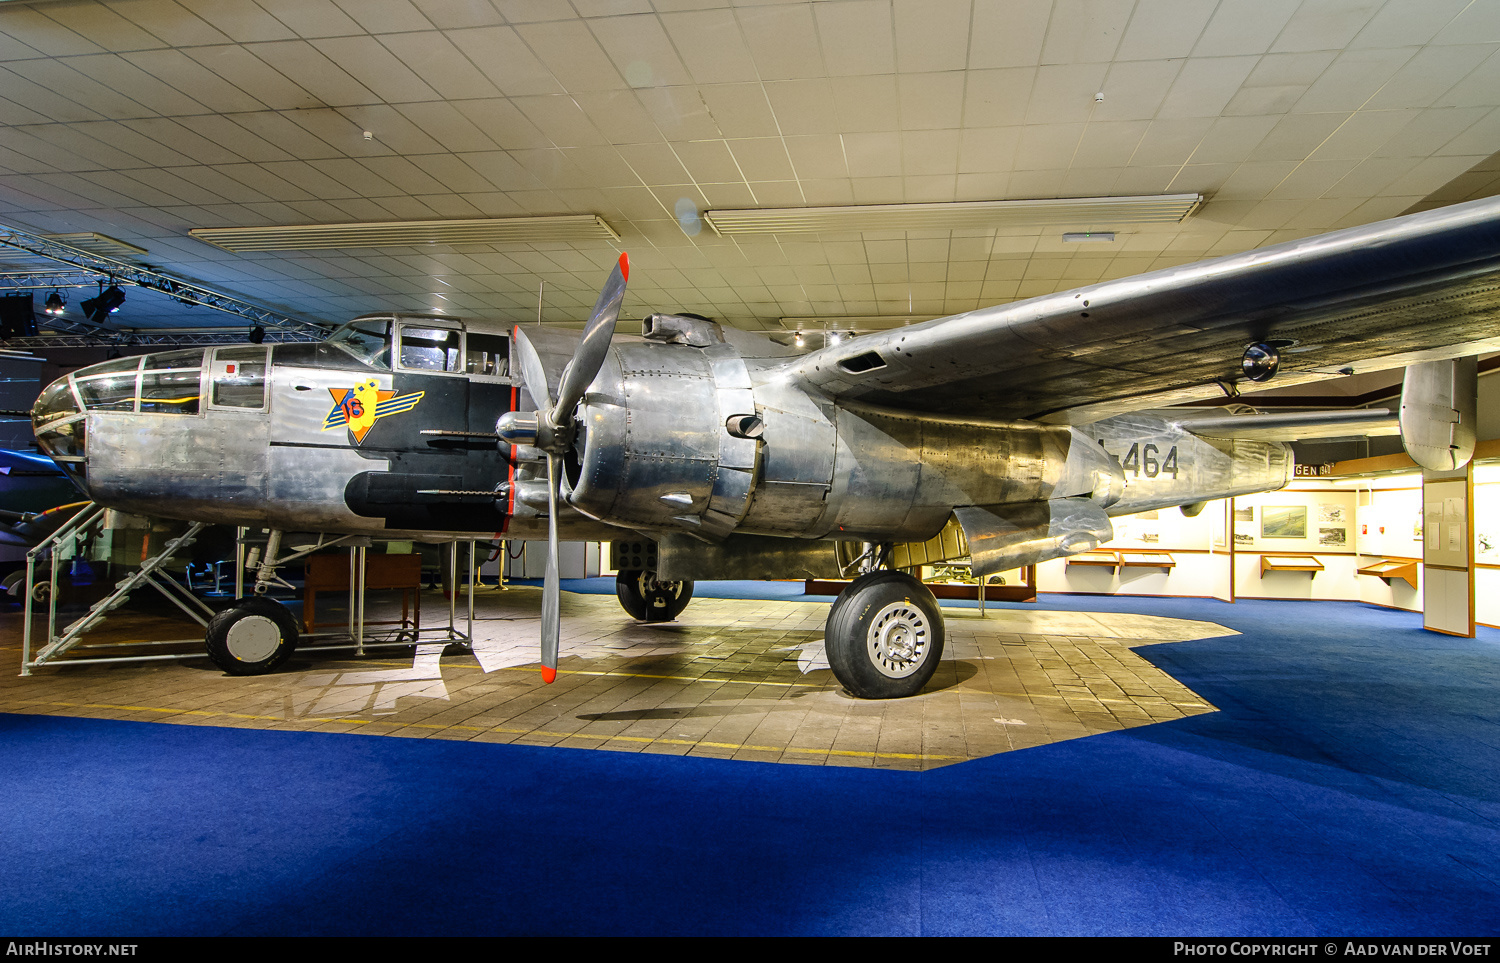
{"left": 0, "top": 597, "right": 1500, "bottom": 936}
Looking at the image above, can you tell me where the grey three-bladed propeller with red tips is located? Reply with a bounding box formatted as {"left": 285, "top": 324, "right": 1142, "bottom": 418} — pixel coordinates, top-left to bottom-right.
{"left": 495, "top": 254, "right": 630, "bottom": 684}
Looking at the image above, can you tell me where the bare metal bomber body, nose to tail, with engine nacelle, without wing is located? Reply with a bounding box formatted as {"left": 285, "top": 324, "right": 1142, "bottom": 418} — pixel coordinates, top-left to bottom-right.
{"left": 36, "top": 329, "right": 1292, "bottom": 561}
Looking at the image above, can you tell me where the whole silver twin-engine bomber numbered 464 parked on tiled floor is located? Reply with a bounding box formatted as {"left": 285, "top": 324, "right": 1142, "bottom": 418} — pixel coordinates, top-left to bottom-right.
{"left": 26, "top": 200, "right": 1500, "bottom": 698}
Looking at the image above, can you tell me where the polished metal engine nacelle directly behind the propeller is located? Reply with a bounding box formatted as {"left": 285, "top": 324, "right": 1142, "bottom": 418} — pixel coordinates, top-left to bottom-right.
{"left": 567, "top": 339, "right": 1124, "bottom": 542}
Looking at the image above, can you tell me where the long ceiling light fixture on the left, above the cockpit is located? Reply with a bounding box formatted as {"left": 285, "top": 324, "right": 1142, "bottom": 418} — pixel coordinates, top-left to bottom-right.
{"left": 188, "top": 215, "right": 620, "bottom": 252}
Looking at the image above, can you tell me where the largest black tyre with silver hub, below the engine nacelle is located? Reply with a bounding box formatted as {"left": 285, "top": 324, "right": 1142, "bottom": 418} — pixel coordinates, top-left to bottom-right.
{"left": 824, "top": 572, "right": 944, "bottom": 699}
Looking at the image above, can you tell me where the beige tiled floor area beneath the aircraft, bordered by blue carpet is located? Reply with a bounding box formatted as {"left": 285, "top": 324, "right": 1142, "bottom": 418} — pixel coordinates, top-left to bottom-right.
{"left": 0, "top": 588, "right": 1233, "bottom": 770}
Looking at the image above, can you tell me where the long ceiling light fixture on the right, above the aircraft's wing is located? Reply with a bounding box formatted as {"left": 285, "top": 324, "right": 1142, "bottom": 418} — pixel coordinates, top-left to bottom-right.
{"left": 704, "top": 194, "right": 1203, "bottom": 236}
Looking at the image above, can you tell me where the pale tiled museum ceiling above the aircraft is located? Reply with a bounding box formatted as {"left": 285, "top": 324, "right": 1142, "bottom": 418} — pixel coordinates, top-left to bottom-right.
{"left": 0, "top": 0, "right": 1500, "bottom": 366}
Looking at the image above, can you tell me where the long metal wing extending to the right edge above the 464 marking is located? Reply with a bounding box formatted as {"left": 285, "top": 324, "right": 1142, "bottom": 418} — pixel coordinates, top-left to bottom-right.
{"left": 777, "top": 198, "right": 1500, "bottom": 425}
